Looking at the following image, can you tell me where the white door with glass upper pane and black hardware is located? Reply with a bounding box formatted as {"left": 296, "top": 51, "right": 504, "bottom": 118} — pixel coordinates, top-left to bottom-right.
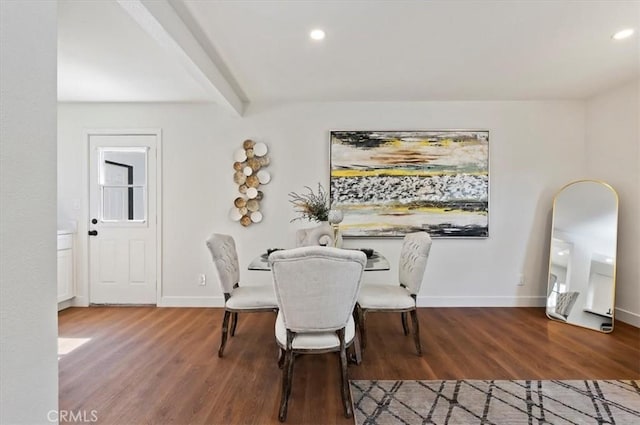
{"left": 88, "top": 134, "right": 159, "bottom": 304}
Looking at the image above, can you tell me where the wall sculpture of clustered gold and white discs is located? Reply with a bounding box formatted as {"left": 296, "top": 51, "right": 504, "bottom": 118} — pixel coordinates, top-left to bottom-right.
{"left": 229, "top": 139, "right": 271, "bottom": 227}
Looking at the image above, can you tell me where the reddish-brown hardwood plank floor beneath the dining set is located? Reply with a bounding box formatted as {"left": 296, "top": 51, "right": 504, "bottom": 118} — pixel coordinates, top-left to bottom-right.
{"left": 59, "top": 307, "right": 640, "bottom": 424}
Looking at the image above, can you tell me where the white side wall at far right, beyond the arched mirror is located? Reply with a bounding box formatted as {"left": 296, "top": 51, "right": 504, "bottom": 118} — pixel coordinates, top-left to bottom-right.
{"left": 586, "top": 80, "right": 640, "bottom": 326}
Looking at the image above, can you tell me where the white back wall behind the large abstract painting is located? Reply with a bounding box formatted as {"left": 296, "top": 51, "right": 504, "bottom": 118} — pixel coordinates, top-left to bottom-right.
{"left": 58, "top": 102, "right": 585, "bottom": 306}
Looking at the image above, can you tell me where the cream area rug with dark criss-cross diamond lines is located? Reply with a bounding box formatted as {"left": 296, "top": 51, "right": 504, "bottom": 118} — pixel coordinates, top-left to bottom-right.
{"left": 350, "top": 380, "right": 640, "bottom": 425}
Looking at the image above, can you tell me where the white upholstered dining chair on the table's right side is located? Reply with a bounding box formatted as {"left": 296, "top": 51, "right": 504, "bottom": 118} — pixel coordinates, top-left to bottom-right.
{"left": 356, "top": 232, "right": 431, "bottom": 356}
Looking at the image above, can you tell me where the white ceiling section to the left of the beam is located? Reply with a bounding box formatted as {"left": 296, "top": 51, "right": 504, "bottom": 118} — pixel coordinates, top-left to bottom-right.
{"left": 58, "top": 0, "right": 208, "bottom": 102}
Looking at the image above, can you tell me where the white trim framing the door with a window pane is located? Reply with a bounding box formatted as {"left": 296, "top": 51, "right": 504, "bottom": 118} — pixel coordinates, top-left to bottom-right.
{"left": 79, "top": 128, "right": 162, "bottom": 307}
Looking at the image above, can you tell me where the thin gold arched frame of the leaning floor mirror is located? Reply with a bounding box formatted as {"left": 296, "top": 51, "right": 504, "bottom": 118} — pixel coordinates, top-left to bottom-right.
{"left": 545, "top": 179, "right": 620, "bottom": 333}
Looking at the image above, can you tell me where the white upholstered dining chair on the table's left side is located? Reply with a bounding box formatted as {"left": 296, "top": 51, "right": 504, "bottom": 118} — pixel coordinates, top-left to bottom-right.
{"left": 207, "top": 233, "right": 278, "bottom": 357}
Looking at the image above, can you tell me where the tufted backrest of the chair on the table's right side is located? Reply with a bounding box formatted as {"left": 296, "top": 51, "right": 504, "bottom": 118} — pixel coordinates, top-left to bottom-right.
{"left": 399, "top": 232, "right": 431, "bottom": 294}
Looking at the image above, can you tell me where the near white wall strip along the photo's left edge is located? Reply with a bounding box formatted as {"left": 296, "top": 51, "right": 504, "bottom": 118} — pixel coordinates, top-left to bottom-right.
{"left": 0, "top": 1, "right": 58, "bottom": 424}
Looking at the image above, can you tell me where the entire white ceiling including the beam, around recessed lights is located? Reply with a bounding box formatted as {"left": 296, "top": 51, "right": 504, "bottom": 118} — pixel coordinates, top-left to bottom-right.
{"left": 58, "top": 0, "right": 640, "bottom": 113}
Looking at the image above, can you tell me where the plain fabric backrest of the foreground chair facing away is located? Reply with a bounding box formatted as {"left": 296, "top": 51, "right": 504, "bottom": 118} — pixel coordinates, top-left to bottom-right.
{"left": 269, "top": 246, "right": 367, "bottom": 332}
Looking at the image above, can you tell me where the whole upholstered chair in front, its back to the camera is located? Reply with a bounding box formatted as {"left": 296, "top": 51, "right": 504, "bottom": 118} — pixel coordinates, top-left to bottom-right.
{"left": 269, "top": 246, "right": 367, "bottom": 422}
